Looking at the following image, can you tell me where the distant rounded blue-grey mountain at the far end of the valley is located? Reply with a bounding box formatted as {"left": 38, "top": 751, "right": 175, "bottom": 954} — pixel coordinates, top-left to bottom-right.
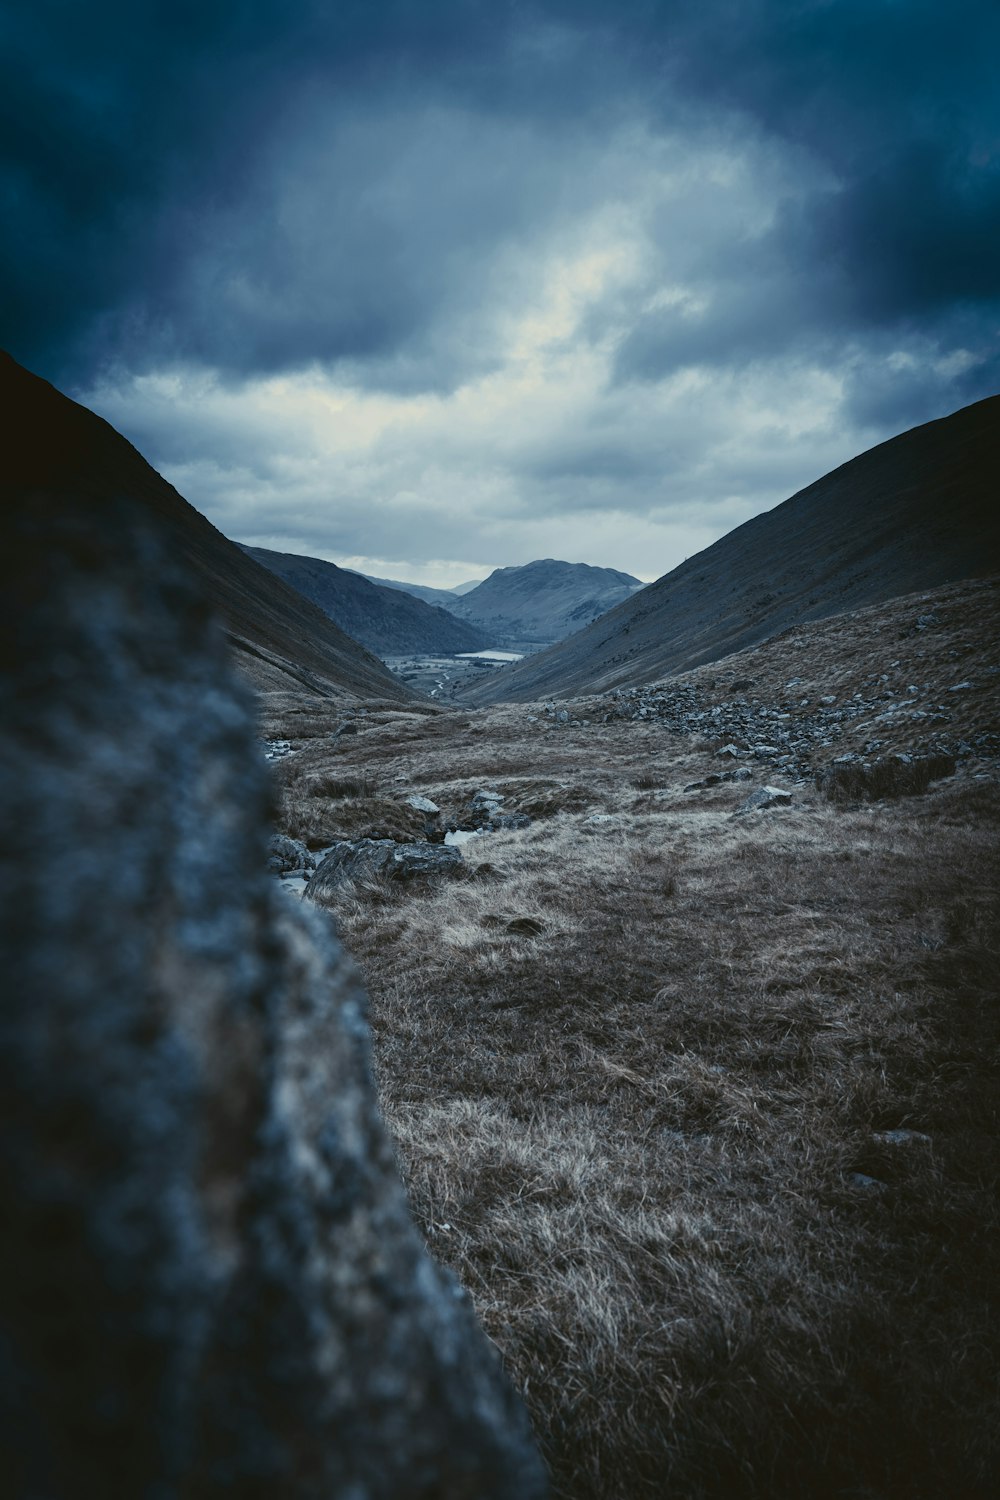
{"left": 448, "top": 558, "right": 645, "bottom": 645}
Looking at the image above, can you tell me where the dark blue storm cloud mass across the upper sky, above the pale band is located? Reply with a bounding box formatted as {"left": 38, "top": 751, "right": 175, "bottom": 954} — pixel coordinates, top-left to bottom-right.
{"left": 0, "top": 0, "right": 1000, "bottom": 435}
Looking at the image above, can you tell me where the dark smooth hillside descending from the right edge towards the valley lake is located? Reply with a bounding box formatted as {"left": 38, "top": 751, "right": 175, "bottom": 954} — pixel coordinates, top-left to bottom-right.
{"left": 463, "top": 396, "right": 1000, "bottom": 704}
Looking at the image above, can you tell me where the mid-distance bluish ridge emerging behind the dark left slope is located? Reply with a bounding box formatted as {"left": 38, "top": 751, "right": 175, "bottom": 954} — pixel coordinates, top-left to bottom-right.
{"left": 238, "top": 543, "right": 492, "bottom": 656}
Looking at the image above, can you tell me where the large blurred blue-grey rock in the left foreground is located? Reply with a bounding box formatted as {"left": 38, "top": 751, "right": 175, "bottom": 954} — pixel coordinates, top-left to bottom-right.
{"left": 0, "top": 488, "right": 543, "bottom": 1500}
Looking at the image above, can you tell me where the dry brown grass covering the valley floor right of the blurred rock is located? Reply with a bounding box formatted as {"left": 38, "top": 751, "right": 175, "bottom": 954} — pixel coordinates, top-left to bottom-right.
{"left": 265, "top": 576, "right": 1000, "bottom": 1500}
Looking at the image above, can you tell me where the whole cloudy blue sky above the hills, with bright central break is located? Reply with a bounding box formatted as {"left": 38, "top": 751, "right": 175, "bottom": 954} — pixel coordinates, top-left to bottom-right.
{"left": 0, "top": 0, "right": 1000, "bottom": 588}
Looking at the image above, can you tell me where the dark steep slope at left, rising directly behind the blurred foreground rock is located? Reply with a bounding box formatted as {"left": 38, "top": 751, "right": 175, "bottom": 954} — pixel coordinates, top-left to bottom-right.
{"left": 0, "top": 353, "right": 414, "bottom": 699}
